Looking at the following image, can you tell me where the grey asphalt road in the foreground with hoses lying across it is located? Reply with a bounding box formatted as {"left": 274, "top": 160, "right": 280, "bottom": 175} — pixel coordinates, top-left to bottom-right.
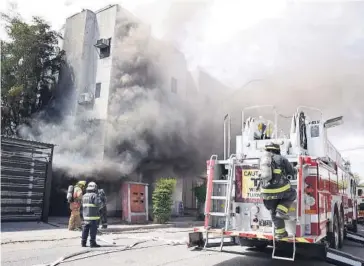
{"left": 1, "top": 224, "right": 364, "bottom": 266}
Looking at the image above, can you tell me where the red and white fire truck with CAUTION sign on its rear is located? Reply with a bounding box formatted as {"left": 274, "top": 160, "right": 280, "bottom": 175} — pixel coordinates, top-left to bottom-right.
{"left": 189, "top": 106, "right": 364, "bottom": 265}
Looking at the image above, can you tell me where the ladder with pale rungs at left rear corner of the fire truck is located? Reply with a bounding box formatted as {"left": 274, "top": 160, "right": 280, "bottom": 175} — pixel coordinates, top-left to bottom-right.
{"left": 204, "top": 154, "right": 235, "bottom": 251}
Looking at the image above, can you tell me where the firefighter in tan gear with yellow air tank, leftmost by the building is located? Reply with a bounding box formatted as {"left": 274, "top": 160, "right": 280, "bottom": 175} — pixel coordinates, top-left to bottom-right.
{"left": 68, "top": 181, "right": 86, "bottom": 230}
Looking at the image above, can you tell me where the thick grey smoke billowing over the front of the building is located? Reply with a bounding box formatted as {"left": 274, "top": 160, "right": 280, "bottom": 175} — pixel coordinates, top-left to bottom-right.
{"left": 20, "top": 6, "right": 226, "bottom": 179}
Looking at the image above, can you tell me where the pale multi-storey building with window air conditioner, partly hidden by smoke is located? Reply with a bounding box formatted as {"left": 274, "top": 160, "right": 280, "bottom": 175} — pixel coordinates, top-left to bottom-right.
{"left": 60, "top": 5, "right": 230, "bottom": 214}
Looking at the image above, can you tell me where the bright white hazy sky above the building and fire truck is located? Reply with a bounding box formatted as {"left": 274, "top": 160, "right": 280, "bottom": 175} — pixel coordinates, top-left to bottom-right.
{"left": 0, "top": 0, "right": 364, "bottom": 176}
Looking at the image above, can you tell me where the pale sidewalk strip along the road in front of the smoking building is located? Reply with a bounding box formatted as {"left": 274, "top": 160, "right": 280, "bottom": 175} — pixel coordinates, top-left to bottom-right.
{"left": 1, "top": 217, "right": 203, "bottom": 245}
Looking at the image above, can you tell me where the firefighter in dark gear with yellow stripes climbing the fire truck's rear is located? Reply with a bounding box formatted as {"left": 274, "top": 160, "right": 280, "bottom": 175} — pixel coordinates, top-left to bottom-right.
{"left": 260, "top": 143, "right": 297, "bottom": 238}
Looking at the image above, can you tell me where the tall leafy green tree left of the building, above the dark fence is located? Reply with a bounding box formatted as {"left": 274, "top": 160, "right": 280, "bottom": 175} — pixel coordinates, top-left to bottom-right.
{"left": 1, "top": 13, "right": 64, "bottom": 135}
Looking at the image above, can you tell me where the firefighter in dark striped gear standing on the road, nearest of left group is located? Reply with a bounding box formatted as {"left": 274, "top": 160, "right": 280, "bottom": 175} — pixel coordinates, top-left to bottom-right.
{"left": 81, "top": 182, "right": 100, "bottom": 248}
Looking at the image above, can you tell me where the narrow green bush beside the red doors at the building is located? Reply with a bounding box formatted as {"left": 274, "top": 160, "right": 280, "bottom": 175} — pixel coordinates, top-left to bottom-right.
{"left": 152, "top": 178, "right": 176, "bottom": 224}
